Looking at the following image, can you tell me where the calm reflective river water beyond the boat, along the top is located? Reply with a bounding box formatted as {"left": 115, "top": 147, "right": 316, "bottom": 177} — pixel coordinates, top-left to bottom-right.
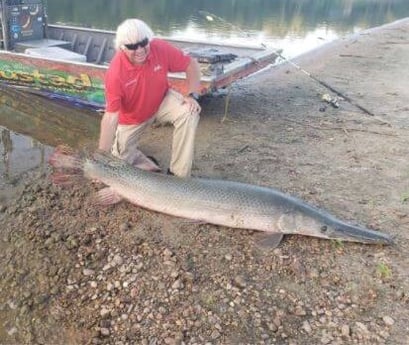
{"left": 48, "top": 0, "right": 409, "bottom": 57}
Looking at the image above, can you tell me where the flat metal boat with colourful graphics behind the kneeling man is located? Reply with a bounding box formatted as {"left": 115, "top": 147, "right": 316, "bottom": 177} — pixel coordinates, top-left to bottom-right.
{"left": 0, "top": 0, "right": 280, "bottom": 111}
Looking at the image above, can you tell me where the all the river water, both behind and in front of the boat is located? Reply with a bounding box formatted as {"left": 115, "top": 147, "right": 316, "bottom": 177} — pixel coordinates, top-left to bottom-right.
{"left": 0, "top": 0, "right": 409, "bottom": 189}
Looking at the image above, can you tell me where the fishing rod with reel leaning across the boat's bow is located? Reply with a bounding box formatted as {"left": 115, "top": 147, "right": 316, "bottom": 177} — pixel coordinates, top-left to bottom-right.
{"left": 198, "top": 10, "right": 375, "bottom": 116}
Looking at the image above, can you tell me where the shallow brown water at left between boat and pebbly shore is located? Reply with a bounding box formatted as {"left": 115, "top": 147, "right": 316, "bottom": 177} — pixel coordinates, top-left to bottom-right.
{"left": 0, "top": 88, "right": 99, "bottom": 199}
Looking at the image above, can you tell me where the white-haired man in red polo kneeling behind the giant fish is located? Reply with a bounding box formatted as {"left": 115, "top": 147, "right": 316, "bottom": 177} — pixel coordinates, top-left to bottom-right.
{"left": 99, "top": 19, "right": 201, "bottom": 177}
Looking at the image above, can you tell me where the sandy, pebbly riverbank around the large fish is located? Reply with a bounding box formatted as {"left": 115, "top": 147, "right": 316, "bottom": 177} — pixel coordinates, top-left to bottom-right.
{"left": 0, "top": 20, "right": 409, "bottom": 345}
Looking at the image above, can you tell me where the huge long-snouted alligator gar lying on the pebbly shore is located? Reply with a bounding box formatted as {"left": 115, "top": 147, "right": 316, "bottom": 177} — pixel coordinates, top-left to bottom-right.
{"left": 50, "top": 149, "right": 393, "bottom": 245}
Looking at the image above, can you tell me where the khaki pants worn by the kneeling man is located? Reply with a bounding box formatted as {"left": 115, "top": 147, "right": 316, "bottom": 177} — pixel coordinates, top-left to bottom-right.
{"left": 112, "top": 89, "right": 199, "bottom": 177}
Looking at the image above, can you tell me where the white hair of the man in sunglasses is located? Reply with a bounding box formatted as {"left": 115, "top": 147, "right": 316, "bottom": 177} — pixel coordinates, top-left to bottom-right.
{"left": 115, "top": 18, "right": 153, "bottom": 50}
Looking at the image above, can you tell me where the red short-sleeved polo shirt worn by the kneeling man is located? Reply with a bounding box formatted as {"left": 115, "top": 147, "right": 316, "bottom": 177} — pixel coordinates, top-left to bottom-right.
{"left": 105, "top": 38, "right": 190, "bottom": 125}
